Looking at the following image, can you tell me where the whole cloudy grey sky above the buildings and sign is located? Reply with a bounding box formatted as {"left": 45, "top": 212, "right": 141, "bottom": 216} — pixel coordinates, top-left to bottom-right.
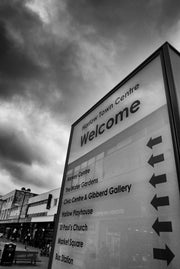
{"left": 0, "top": 0, "right": 180, "bottom": 194}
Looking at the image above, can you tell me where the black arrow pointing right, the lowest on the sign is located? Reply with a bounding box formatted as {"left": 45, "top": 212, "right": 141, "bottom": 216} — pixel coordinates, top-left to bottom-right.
{"left": 153, "top": 245, "right": 175, "bottom": 265}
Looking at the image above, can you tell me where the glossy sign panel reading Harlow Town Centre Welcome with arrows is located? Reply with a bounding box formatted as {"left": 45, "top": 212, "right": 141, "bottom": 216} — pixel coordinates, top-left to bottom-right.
{"left": 52, "top": 57, "right": 180, "bottom": 269}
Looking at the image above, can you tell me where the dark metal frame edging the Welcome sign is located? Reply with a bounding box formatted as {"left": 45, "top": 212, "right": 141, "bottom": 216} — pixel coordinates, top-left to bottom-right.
{"left": 48, "top": 42, "right": 180, "bottom": 269}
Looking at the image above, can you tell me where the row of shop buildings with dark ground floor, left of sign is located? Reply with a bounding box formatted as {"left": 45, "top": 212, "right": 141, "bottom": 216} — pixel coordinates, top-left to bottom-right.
{"left": 0, "top": 188, "right": 60, "bottom": 248}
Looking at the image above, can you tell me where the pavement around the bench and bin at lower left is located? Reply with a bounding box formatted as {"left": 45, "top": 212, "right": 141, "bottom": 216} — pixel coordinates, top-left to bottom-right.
{"left": 0, "top": 240, "right": 49, "bottom": 269}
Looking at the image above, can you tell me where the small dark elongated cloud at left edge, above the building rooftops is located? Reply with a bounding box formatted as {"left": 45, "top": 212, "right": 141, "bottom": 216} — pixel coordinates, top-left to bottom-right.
{"left": 0, "top": 125, "right": 45, "bottom": 165}
